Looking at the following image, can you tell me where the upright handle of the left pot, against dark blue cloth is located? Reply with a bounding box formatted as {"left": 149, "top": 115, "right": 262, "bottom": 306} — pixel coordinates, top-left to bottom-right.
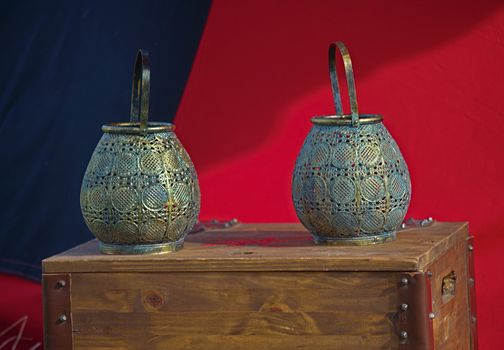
{"left": 130, "top": 49, "right": 150, "bottom": 130}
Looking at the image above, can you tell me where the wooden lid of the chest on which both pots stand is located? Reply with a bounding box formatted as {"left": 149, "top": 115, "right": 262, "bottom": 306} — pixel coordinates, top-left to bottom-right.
{"left": 42, "top": 222, "right": 467, "bottom": 273}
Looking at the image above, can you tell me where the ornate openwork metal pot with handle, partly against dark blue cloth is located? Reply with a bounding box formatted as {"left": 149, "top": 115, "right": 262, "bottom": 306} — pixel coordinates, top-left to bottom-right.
{"left": 80, "top": 50, "right": 200, "bottom": 254}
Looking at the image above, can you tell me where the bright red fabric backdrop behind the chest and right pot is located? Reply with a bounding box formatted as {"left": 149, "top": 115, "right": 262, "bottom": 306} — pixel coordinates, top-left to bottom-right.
{"left": 0, "top": 0, "right": 504, "bottom": 350}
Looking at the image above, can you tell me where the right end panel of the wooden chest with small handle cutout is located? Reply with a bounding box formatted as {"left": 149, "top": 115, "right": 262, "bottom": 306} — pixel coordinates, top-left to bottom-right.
{"left": 429, "top": 223, "right": 471, "bottom": 350}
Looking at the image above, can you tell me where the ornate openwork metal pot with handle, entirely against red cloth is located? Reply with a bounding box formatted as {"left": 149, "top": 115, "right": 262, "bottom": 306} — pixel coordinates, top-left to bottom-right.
{"left": 292, "top": 42, "right": 411, "bottom": 245}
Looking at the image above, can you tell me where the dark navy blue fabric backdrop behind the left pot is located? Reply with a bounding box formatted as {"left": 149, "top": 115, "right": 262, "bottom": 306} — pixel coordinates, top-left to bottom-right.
{"left": 0, "top": 0, "right": 210, "bottom": 280}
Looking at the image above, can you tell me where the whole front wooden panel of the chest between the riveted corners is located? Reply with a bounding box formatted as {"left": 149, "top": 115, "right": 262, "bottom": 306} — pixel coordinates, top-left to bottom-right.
{"left": 72, "top": 272, "right": 399, "bottom": 349}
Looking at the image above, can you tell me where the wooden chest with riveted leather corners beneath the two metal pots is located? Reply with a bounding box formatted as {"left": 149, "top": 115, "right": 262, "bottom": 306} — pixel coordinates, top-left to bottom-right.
{"left": 42, "top": 222, "right": 477, "bottom": 350}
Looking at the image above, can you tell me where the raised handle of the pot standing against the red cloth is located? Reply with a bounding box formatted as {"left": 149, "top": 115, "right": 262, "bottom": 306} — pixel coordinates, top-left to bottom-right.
{"left": 329, "top": 41, "right": 359, "bottom": 126}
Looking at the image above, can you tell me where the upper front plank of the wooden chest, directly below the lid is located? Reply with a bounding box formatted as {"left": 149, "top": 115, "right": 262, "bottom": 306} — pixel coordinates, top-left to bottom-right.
{"left": 73, "top": 272, "right": 396, "bottom": 313}
